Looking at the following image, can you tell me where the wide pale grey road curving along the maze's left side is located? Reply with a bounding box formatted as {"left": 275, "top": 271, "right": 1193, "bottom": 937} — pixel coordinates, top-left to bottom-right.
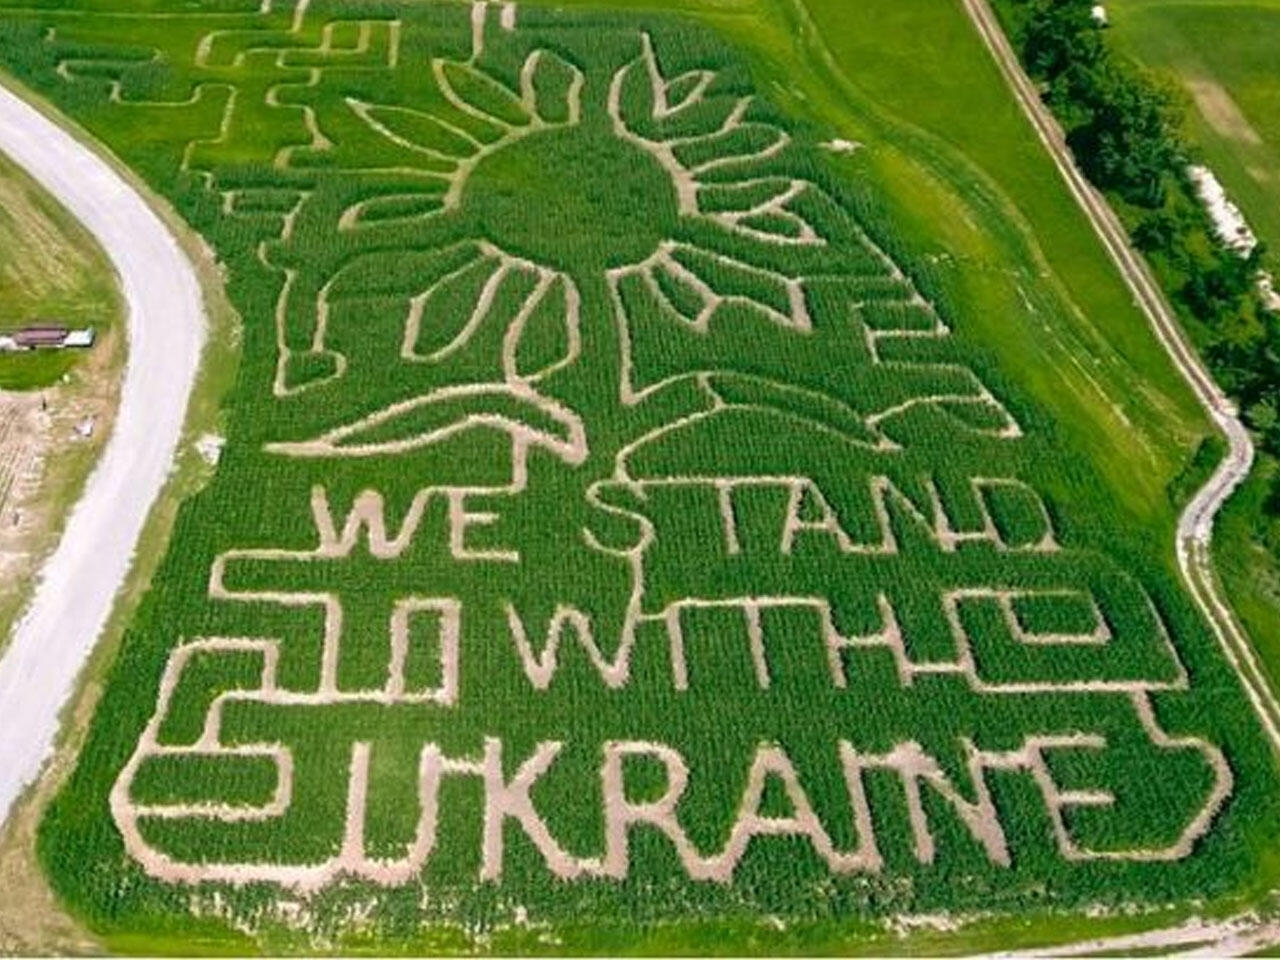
{"left": 0, "top": 86, "right": 206, "bottom": 823}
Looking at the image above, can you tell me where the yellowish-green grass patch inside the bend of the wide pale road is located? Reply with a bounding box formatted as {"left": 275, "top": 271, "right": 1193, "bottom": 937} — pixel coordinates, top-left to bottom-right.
{"left": 0, "top": 146, "right": 119, "bottom": 390}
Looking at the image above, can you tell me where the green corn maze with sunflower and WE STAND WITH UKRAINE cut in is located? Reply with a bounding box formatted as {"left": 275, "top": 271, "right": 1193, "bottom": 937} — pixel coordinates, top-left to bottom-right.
{"left": 0, "top": 0, "right": 1274, "bottom": 938}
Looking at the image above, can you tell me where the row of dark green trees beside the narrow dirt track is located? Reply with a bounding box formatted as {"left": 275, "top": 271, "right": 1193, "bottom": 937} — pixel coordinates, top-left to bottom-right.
{"left": 998, "top": 0, "right": 1280, "bottom": 506}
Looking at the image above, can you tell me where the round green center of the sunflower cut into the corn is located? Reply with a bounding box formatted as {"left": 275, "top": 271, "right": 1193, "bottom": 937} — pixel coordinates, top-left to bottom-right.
{"left": 462, "top": 124, "right": 680, "bottom": 275}
